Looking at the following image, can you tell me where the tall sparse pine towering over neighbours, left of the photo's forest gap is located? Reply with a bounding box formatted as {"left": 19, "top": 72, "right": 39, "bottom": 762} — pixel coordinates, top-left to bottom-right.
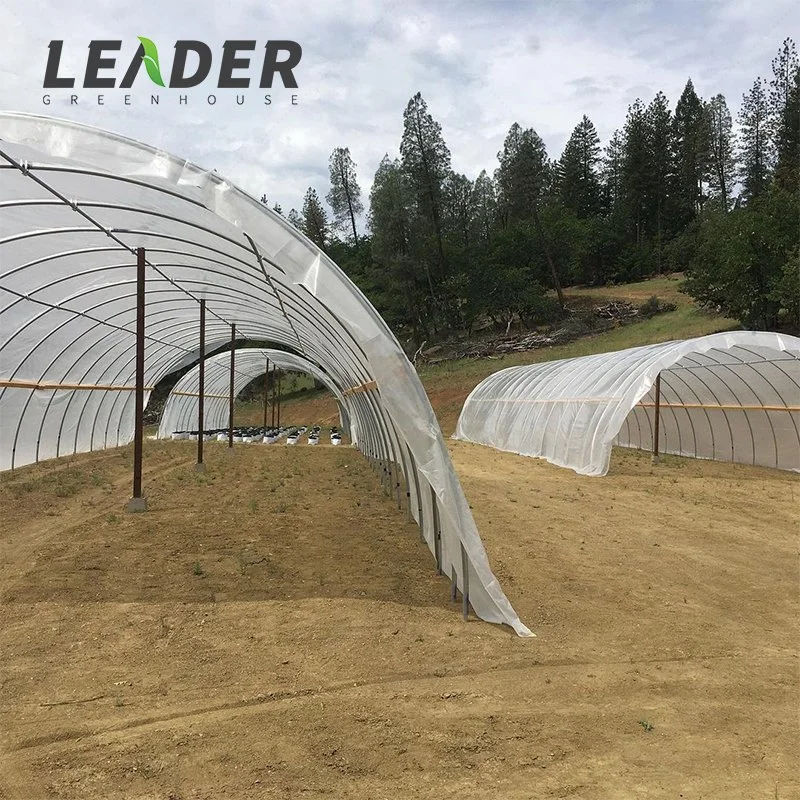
{"left": 400, "top": 92, "right": 450, "bottom": 278}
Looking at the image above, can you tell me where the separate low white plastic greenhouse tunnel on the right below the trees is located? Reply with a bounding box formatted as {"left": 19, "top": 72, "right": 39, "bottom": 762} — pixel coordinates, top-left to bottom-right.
{"left": 454, "top": 331, "right": 800, "bottom": 476}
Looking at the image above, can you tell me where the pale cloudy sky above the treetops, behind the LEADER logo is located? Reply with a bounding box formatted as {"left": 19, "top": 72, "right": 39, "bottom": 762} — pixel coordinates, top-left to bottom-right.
{"left": 0, "top": 0, "right": 800, "bottom": 219}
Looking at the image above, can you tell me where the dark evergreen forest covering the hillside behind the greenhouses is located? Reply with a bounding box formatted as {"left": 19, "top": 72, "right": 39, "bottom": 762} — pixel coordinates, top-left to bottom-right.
{"left": 270, "top": 39, "right": 800, "bottom": 346}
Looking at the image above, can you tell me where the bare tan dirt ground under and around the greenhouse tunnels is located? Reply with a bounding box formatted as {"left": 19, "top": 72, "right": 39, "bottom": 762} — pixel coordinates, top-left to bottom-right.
{"left": 0, "top": 434, "right": 800, "bottom": 800}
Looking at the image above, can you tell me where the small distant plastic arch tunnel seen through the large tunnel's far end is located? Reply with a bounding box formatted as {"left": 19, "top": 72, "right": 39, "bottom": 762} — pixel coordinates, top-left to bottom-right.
{"left": 158, "top": 347, "right": 358, "bottom": 444}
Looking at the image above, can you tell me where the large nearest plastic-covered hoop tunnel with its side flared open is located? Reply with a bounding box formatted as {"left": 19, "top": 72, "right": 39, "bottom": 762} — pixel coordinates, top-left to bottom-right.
{"left": 0, "top": 112, "right": 531, "bottom": 636}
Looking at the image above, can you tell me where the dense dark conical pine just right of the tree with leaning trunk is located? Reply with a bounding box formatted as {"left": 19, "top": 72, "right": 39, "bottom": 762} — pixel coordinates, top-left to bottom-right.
{"left": 558, "top": 115, "right": 600, "bottom": 218}
